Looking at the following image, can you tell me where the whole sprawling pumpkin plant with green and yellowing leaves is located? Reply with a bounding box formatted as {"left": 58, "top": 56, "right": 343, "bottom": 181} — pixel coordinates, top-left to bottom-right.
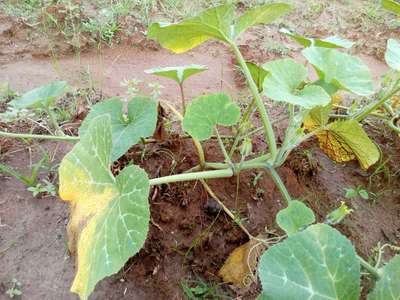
{"left": 0, "top": 3, "right": 400, "bottom": 299}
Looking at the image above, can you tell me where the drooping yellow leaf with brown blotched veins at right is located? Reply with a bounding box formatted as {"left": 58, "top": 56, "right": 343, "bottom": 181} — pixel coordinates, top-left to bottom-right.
{"left": 317, "top": 120, "right": 380, "bottom": 170}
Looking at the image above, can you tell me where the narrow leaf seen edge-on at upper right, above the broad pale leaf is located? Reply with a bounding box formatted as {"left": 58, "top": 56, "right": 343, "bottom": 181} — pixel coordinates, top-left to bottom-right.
{"left": 280, "top": 28, "right": 354, "bottom": 49}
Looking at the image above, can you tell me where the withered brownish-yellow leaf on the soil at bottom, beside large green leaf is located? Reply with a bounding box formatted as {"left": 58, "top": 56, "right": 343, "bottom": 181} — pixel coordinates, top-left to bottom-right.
{"left": 218, "top": 240, "right": 265, "bottom": 288}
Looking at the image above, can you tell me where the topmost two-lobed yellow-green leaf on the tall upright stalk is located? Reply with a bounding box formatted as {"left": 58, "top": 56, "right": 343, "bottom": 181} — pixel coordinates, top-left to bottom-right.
{"left": 148, "top": 3, "right": 290, "bottom": 53}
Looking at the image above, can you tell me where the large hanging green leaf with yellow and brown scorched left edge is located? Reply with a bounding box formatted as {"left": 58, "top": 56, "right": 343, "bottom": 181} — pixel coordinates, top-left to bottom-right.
{"left": 59, "top": 115, "right": 150, "bottom": 300}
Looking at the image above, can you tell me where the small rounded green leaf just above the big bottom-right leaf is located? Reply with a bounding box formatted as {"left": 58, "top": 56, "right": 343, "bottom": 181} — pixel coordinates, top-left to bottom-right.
{"left": 276, "top": 200, "right": 315, "bottom": 236}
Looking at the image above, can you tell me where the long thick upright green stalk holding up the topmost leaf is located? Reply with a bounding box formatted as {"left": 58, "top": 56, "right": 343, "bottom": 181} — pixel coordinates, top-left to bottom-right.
{"left": 230, "top": 43, "right": 278, "bottom": 160}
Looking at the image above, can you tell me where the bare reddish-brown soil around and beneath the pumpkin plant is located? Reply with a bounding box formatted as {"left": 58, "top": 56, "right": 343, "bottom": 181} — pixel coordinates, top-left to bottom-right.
{"left": 0, "top": 1, "right": 400, "bottom": 300}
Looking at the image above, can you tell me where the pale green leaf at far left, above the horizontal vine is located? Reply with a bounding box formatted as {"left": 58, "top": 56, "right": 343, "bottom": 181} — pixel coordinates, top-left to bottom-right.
{"left": 10, "top": 81, "right": 67, "bottom": 108}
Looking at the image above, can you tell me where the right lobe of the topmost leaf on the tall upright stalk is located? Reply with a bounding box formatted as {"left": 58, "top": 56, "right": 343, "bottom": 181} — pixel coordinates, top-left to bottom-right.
{"left": 235, "top": 3, "right": 291, "bottom": 37}
